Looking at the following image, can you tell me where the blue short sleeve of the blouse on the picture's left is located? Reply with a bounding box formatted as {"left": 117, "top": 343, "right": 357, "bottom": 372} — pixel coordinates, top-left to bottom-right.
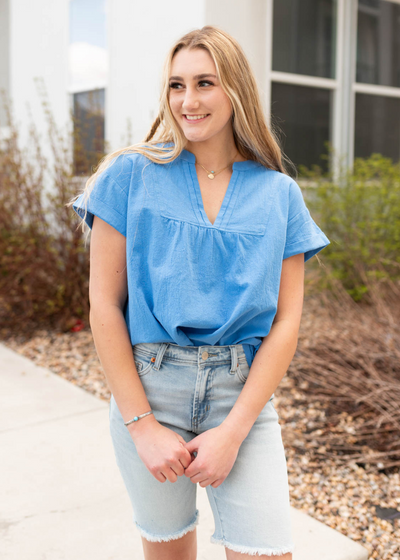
{"left": 72, "top": 156, "right": 130, "bottom": 237}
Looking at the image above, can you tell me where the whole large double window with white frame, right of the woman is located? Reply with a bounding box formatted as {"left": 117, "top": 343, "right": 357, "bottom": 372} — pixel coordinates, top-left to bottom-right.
{"left": 267, "top": 0, "right": 400, "bottom": 177}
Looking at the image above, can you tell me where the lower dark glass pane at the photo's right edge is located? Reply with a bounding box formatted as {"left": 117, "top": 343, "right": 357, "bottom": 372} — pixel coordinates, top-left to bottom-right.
{"left": 354, "top": 93, "right": 400, "bottom": 162}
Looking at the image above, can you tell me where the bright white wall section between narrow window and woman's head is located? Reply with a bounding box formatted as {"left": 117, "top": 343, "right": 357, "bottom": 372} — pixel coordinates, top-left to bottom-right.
{"left": 106, "top": 0, "right": 205, "bottom": 150}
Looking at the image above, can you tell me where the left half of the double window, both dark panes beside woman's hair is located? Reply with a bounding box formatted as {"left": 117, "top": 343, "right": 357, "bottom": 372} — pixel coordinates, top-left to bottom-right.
{"left": 270, "top": 0, "right": 337, "bottom": 175}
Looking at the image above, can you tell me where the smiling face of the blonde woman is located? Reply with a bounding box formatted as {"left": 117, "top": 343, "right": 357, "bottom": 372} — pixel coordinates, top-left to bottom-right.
{"left": 169, "top": 49, "right": 232, "bottom": 142}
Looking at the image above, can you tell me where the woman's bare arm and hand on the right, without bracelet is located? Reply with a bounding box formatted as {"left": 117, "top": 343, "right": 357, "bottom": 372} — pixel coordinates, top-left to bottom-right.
{"left": 185, "top": 253, "right": 304, "bottom": 487}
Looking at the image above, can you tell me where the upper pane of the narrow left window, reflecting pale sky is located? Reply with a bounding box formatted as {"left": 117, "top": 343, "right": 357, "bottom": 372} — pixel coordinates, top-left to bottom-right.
{"left": 69, "top": 0, "right": 108, "bottom": 90}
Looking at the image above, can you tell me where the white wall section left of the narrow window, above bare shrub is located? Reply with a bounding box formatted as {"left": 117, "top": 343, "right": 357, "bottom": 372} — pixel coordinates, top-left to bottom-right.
{"left": 9, "top": 0, "right": 69, "bottom": 166}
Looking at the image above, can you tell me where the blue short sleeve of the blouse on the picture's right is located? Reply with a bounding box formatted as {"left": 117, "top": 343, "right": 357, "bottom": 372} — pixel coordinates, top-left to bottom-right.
{"left": 283, "top": 180, "right": 330, "bottom": 262}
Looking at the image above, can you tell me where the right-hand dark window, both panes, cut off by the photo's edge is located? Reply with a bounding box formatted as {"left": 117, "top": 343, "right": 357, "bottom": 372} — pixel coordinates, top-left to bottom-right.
{"left": 354, "top": 0, "right": 400, "bottom": 162}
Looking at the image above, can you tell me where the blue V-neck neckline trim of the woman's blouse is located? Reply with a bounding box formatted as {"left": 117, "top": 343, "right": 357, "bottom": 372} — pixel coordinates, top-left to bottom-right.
{"left": 181, "top": 149, "right": 253, "bottom": 229}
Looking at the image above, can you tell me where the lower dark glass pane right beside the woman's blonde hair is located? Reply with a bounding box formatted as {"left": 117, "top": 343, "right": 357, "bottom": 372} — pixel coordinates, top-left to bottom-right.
{"left": 271, "top": 83, "right": 332, "bottom": 176}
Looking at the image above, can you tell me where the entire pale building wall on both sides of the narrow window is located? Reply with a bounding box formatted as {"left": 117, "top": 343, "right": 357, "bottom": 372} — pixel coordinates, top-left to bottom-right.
{"left": 0, "top": 0, "right": 266, "bottom": 167}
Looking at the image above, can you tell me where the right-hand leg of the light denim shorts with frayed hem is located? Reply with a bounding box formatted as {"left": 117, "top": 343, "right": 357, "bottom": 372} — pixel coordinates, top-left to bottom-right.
{"left": 204, "top": 360, "right": 294, "bottom": 555}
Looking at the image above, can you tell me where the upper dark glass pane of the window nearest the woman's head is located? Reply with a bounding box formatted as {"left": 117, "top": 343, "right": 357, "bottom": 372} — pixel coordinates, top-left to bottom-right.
{"left": 272, "top": 0, "right": 337, "bottom": 78}
